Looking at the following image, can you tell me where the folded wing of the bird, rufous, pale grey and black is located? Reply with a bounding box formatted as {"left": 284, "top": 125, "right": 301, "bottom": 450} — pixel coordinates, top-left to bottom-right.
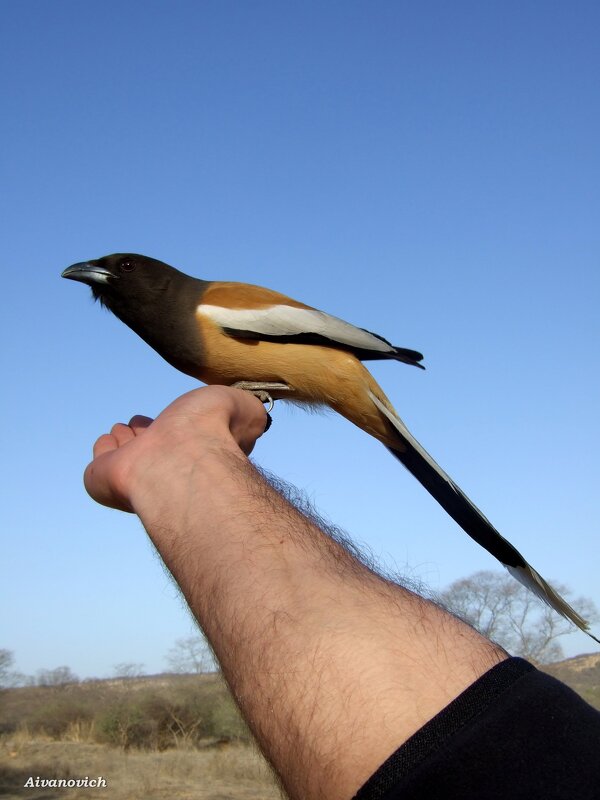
{"left": 198, "top": 283, "right": 423, "bottom": 361}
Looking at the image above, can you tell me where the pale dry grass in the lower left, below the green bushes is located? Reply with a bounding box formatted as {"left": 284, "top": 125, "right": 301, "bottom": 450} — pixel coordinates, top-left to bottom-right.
{"left": 0, "top": 731, "right": 281, "bottom": 800}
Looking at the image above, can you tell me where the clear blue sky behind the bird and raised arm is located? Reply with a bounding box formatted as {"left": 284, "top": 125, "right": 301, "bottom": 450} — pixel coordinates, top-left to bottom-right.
{"left": 0, "top": 0, "right": 600, "bottom": 676}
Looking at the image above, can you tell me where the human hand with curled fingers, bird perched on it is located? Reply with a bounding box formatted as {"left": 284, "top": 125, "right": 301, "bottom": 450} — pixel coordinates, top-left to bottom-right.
{"left": 84, "top": 386, "right": 266, "bottom": 513}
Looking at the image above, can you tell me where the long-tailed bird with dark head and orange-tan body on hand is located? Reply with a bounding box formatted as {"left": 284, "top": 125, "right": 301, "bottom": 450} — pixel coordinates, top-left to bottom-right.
{"left": 61, "top": 253, "right": 600, "bottom": 644}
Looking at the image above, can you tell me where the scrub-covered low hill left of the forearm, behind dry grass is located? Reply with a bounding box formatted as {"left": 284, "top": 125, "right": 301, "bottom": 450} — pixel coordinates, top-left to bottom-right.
{"left": 0, "top": 673, "right": 251, "bottom": 750}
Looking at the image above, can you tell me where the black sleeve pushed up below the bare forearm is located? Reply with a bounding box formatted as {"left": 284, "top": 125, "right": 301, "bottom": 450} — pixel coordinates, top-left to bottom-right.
{"left": 354, "top": 658, "right": 600, "bottom": 800}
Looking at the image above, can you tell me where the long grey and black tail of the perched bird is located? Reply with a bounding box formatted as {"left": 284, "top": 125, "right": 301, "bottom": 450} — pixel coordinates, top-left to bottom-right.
{"left": 367, "top": 390, "right": 600, "bottom": 644}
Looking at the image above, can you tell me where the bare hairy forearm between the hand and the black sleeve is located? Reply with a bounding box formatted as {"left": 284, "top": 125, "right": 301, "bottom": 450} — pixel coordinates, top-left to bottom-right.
{"left": 127, "top": 438, "right": 504, "bottom": 800}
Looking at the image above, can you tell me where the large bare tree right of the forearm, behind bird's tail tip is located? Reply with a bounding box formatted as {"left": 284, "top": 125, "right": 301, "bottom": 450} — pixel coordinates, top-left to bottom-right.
{"left": 438, "top": 571, "right": 599, "bottom": 664}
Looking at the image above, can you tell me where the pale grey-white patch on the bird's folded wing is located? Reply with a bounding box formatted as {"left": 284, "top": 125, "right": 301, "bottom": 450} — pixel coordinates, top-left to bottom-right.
{"left": 196, "top": 303, "right": 394, "bottom": 353}
